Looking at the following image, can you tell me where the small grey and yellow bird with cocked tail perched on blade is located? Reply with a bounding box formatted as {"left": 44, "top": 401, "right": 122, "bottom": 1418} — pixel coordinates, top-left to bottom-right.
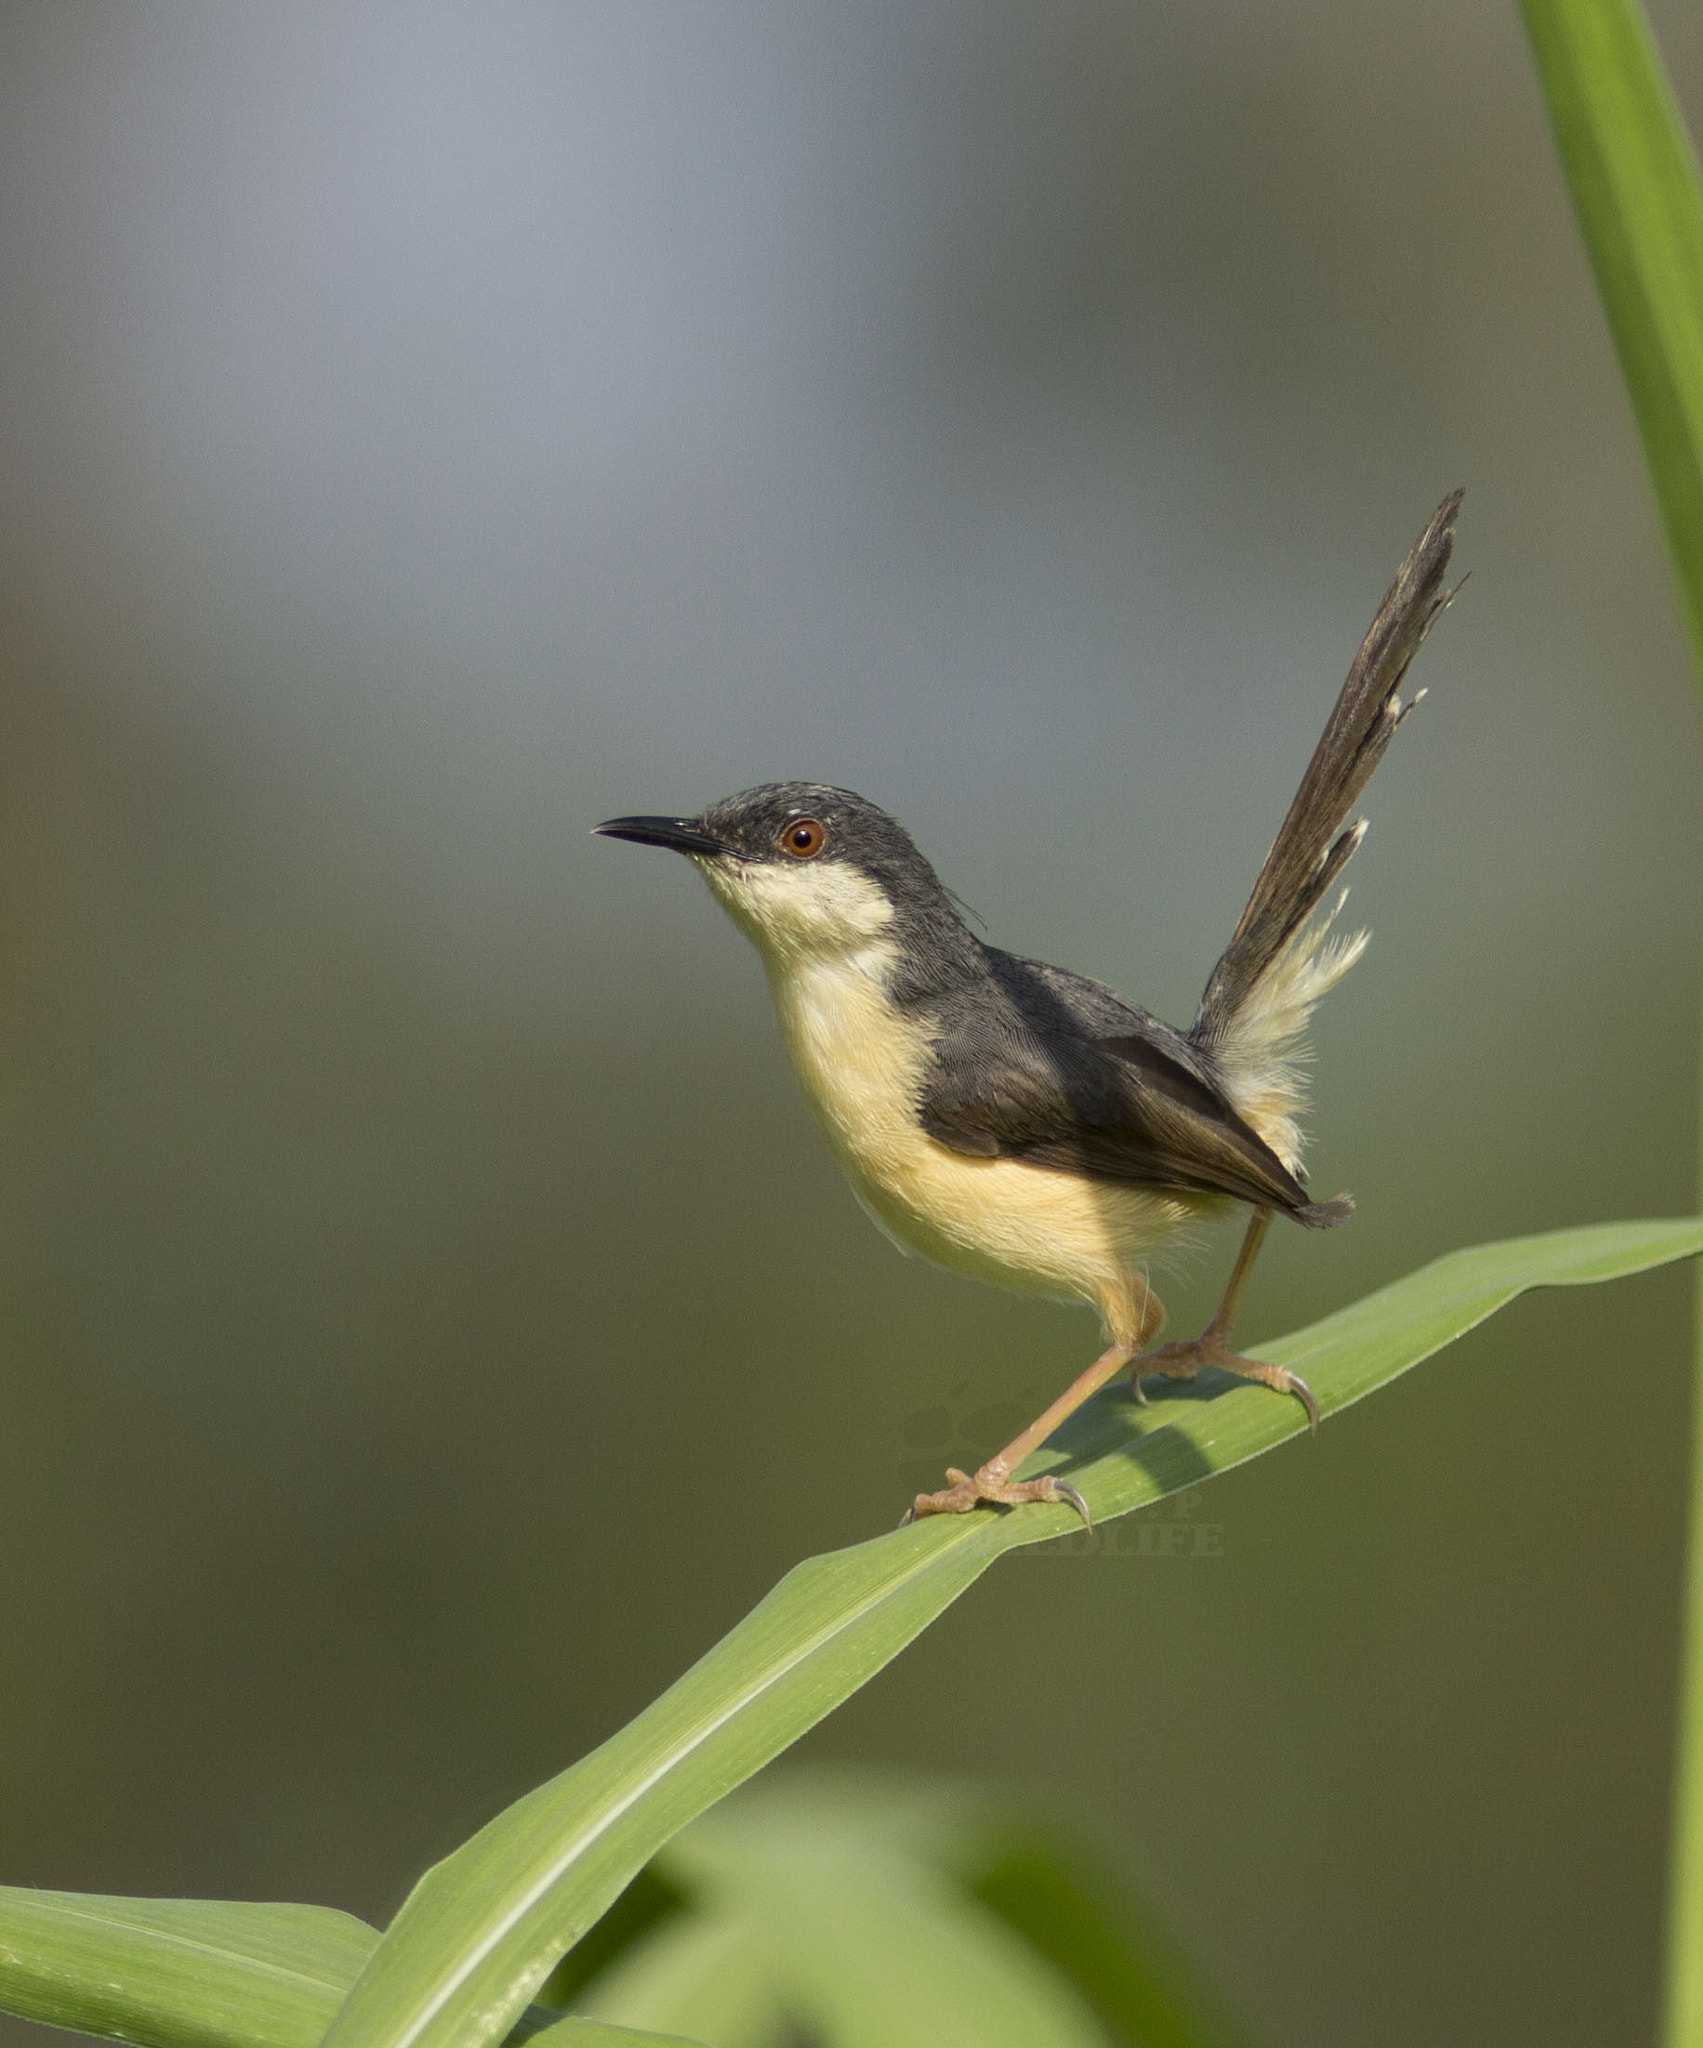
{"left": 596, "top": 492, "right": 1461, "bottom": 1522}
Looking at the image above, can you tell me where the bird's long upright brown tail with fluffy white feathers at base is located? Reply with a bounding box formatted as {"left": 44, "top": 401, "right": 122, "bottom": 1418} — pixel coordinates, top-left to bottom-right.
{"left": 1189, "top": 492, "right": 1461, "bottom": 1171}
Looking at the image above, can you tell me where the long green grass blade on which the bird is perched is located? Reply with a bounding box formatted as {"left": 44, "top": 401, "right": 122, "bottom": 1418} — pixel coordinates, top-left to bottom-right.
{"left": 325, "top": 1217, "right": 1703, "bottom": 2048}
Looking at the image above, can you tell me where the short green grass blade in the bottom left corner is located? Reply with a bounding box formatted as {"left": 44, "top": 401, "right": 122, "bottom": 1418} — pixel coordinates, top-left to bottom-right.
{"left": 0, "top": 1886, "right": 379, "bottom": 2048}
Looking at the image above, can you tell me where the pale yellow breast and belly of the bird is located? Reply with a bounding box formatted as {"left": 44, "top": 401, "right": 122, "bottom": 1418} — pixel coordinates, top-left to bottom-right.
{"left": 770, "top": 942, "right": 1222, "bottom": 1341}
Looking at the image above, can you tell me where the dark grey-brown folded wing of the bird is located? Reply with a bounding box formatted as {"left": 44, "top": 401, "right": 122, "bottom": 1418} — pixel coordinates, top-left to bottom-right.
{"left": 919, "top": 956, "right": 1308, "bottom": 1212}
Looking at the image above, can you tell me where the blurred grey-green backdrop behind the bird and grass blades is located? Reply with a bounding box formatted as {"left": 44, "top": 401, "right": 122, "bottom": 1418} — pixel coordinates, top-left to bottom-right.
{"left": 0, "top": 0, "right": 1703, "bottom": 2048}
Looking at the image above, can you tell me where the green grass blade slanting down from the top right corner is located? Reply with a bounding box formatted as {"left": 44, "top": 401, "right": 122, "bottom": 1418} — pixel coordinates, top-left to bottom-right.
{"left": 1521, "top": 0, "right": 1703, "bottom": 679}
